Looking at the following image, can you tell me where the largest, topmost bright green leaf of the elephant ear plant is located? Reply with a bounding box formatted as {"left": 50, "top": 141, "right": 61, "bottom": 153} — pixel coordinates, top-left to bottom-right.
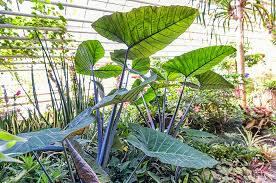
{"left": 92, "top": 6, "right": 198, "bottom": 58}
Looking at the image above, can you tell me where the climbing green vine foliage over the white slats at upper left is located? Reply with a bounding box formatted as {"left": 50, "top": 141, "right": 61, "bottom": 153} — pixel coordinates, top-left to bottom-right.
{"left": 0, "top": 1, "right": 70, "bottom": 58}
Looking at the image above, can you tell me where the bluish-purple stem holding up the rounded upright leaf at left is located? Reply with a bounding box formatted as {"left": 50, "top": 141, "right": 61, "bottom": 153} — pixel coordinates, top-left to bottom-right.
{"left": 91, "top": 65, "right": 103, "bottom": 159}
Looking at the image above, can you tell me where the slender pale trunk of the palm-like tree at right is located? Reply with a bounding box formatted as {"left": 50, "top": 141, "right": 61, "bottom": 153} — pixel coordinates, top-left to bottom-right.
{"left": 236, "top": 0, "right": 246, "bottom": 108}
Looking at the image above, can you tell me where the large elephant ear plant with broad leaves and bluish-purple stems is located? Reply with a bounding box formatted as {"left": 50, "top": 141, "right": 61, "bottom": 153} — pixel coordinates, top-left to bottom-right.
{"left": 0, "top": 6, "right": 235, "bottom": 182}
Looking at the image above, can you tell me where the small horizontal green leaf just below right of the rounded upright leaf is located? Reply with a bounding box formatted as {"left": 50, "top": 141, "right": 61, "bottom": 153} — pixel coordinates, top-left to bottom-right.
{"left": 94, "top": 64, "right": 122, "bottom": 79}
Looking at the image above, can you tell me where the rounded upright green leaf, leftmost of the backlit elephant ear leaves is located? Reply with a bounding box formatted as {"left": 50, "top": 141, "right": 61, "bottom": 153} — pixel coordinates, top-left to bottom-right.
{"left": 75, "top": 40, "right": 104, "bottom": 75}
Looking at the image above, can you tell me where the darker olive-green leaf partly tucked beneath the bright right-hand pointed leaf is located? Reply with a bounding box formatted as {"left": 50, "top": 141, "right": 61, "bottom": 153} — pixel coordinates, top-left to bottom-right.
{"left": 195, "top": 71, "right": 234, "bottom": 90}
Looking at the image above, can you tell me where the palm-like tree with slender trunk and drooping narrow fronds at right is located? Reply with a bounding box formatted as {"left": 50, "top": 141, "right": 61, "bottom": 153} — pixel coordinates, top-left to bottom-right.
{"left": 191, "top": 0, "right": 276, "bottom": 108}
